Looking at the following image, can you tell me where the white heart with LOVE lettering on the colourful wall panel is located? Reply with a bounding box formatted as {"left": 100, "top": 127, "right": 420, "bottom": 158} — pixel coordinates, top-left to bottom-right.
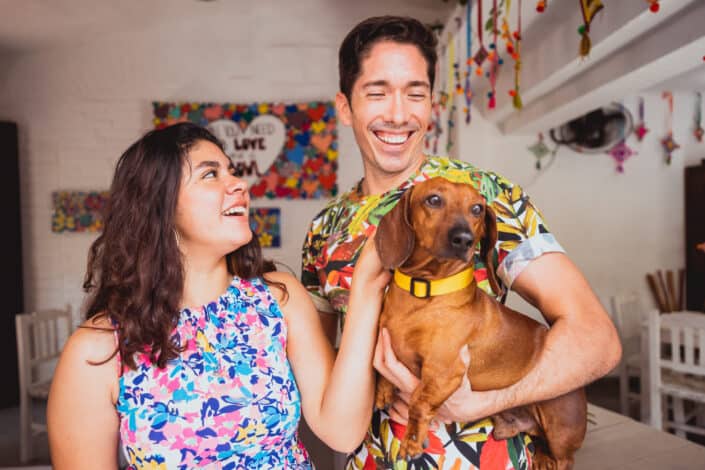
{"left": 207, "top": 114, "right": 286, "bottom": 186}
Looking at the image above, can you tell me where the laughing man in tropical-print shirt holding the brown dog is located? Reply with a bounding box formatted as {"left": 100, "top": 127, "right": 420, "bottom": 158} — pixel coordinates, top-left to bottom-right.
{"left": 302, "top": 17, "right": 621, "bottom": 470}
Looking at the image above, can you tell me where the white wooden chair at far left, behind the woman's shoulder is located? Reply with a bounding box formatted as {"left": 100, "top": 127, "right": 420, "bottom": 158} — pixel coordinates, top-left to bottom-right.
{"left": 15, "top": 305, "right": 72, "bottom": 463}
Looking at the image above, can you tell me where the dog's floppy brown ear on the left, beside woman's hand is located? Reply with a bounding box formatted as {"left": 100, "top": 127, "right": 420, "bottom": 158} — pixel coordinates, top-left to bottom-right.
{"left": 375, "top": 188, "right": 414, "bottom": 269}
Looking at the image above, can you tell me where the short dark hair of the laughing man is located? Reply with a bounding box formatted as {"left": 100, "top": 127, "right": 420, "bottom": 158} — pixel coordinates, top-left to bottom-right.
{"left": 338, "top": 16, "right": 438, "bottom": 101}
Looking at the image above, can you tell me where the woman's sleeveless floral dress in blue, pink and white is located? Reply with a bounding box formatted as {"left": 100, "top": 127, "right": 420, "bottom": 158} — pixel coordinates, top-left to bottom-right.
{"left": 117, "top": 277, "right": 312, "bottom": 470}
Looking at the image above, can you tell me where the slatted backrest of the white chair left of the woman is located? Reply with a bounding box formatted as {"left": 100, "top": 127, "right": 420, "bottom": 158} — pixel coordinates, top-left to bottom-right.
{"left": 15, "top": 305, "right": 72, "bottom": 388}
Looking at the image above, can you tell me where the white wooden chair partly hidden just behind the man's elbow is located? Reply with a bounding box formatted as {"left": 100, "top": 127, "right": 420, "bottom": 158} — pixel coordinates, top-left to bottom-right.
{"left": 610, "top": 293, "right": 646, "bottom": 419}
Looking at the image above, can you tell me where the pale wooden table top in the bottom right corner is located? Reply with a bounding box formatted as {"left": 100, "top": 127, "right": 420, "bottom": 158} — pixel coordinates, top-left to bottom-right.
{"left": 574, "top": 404, "right": 705, "bottom": 470}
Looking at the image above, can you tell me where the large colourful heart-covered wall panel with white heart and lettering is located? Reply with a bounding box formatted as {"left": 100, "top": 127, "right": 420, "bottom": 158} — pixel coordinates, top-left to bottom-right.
{"left": 153, "top": 101, "right": 338, "bottom": 199}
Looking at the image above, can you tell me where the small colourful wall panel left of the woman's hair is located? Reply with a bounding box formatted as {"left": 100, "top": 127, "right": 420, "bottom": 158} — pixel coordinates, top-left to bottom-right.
{"left": 51, "top": 191, "right": 108, "bottom": 233}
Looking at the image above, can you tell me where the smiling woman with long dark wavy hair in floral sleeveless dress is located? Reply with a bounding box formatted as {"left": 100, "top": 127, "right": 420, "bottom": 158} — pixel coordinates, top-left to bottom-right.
{"left": 47, "top": 123, "right": 389, "bottom": 470}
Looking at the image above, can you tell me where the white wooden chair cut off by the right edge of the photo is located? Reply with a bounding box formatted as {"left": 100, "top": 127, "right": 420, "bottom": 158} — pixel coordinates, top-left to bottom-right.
{"left": 648, "top": 311, "right": 705, "bottom": 437}
